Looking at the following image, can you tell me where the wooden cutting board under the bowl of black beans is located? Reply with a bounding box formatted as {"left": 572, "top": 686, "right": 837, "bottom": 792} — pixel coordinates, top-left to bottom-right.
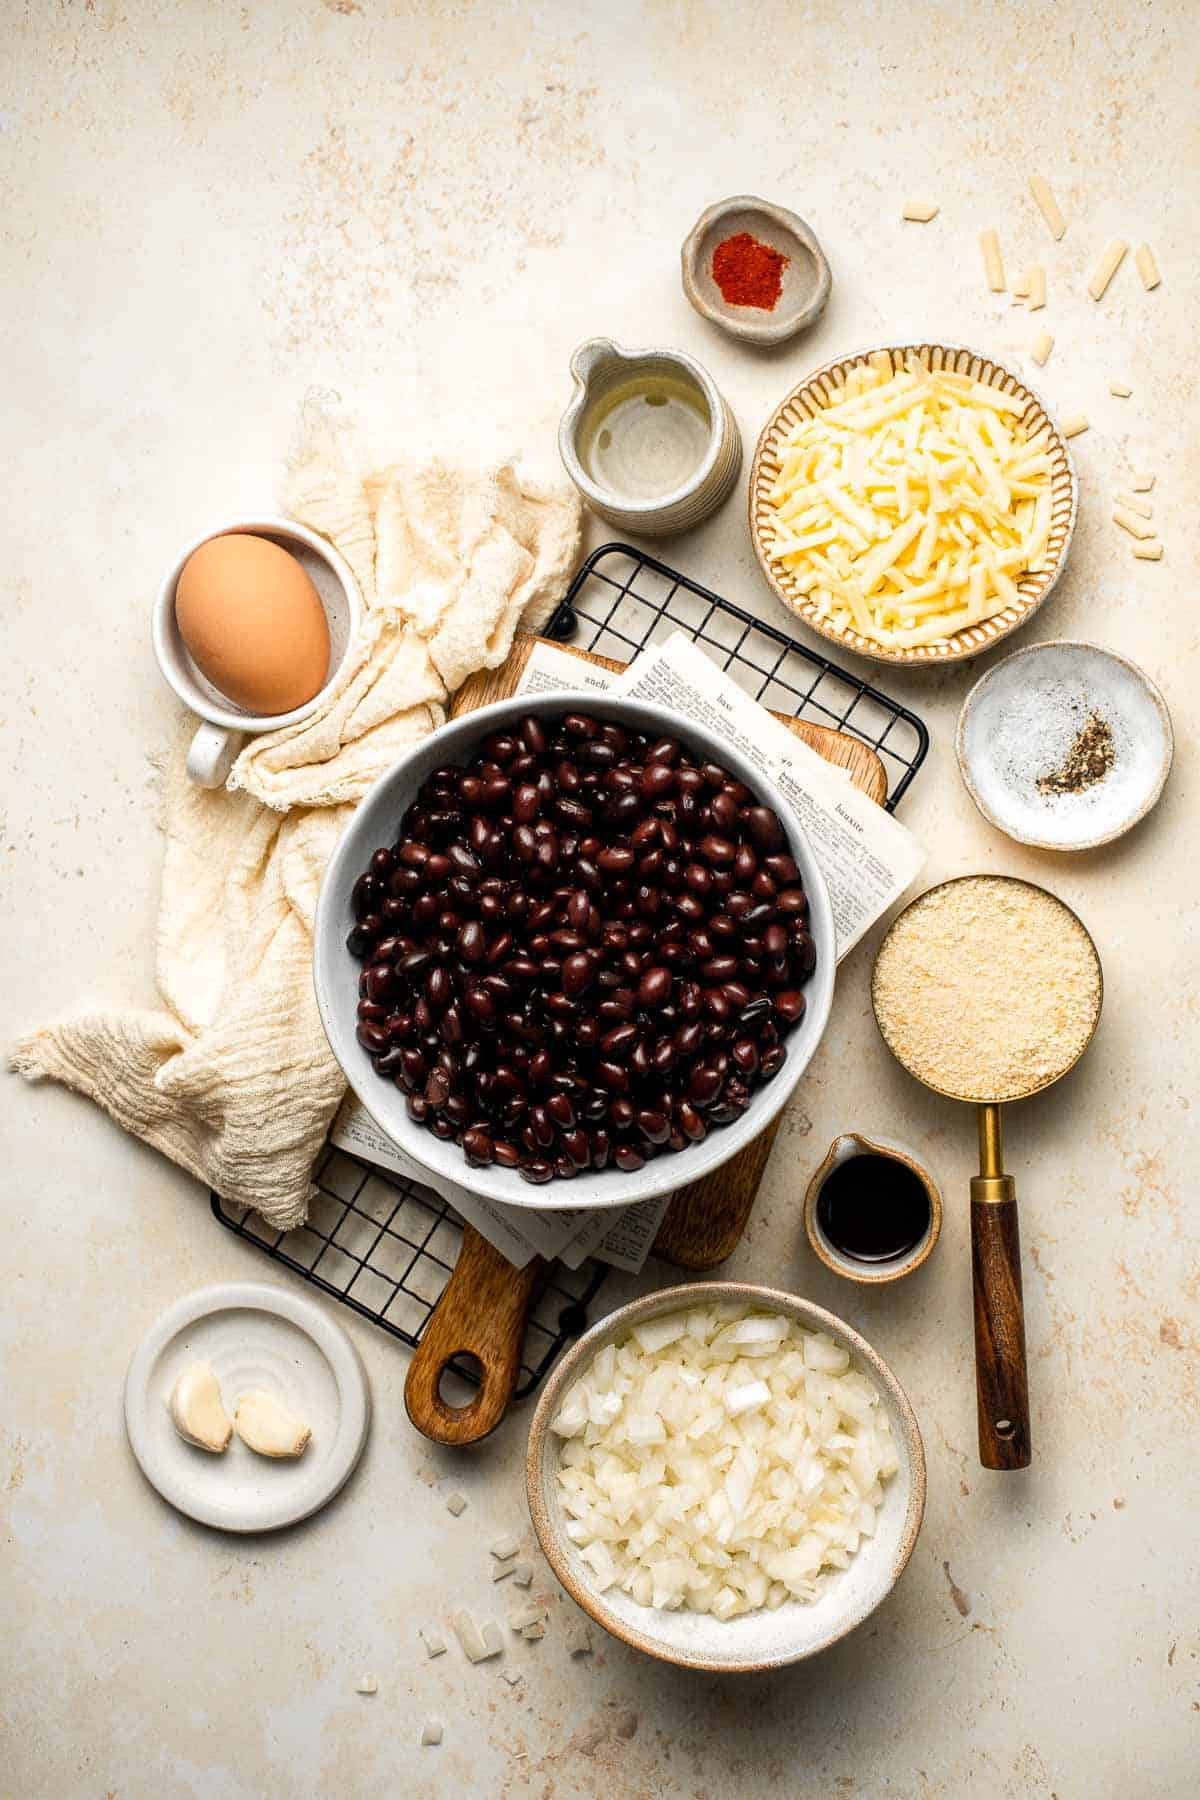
{"left": 405, "top": 632, "right": 887, "bottom": 1445}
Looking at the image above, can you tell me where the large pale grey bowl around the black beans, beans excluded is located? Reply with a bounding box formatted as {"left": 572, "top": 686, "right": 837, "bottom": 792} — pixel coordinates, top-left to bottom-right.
{"left": 313, "top": 693, "right": 837, "bottom": 1211}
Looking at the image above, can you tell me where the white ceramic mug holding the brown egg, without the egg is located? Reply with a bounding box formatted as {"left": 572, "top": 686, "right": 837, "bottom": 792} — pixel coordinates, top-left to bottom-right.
{"left": 153, "top": 517, "right": 362, "bottom": 787}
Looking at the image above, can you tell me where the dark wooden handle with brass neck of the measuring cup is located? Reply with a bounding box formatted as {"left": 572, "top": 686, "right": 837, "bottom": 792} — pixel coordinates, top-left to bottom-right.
{"left": 972, "top": 1107, "right": 1033, "bottom": 1469}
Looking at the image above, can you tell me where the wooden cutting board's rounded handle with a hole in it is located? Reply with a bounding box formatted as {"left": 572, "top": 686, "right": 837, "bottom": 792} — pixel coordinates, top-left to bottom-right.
{"left": 405, "top": 1226, "right": 543, "bottom": 1445}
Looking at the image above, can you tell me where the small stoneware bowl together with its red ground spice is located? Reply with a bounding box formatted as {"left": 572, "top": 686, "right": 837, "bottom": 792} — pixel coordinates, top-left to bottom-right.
{"left": 682, "top": 194, "right": 831, "bottom": 344}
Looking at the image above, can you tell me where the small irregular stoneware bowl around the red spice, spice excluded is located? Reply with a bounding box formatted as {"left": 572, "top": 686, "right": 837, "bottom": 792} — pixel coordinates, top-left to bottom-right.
{"left": 680, "top": 194, "right": 831, "bottom": 344}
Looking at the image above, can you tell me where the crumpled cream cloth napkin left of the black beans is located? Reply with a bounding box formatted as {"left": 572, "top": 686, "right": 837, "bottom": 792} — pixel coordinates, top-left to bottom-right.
{"left": 13, "top": 414, "right": 579, "bottom": 1229}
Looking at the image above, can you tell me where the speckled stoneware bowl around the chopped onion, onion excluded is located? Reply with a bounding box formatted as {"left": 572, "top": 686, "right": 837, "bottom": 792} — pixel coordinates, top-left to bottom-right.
{"left": 525, "top": 1282, "right": 925, "bottom": 1674}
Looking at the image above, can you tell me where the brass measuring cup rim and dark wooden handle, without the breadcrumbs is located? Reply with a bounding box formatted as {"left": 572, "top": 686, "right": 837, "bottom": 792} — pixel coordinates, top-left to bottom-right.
{"left": 871, "top": 875, "right": 1103, "bottom": 1469}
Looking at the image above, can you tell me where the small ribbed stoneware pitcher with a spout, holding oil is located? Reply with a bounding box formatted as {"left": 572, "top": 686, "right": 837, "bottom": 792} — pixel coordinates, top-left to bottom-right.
{"left": 558, "top": 338, "right": 741, "bottom": 538}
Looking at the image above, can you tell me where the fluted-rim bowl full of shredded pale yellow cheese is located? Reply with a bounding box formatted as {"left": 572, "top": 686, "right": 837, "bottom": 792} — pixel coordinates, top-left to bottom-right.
{"left": 750, "top": 344, "right": 1078, "bottom": 668}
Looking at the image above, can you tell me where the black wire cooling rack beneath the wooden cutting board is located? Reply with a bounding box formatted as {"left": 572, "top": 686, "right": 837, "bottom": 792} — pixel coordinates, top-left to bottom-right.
{"left": 212, "top": 544, "right": 928, "bottom": 1399}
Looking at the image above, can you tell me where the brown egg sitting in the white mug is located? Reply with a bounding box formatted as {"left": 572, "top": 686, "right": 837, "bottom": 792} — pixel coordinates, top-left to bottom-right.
{"left": 175, "top": 531, "right": 329, "bottom": 715}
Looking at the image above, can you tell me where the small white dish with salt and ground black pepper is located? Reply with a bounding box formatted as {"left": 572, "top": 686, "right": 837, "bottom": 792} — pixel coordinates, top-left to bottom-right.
{"left": 955, "top": 641, "right": 1175, "bottom": 850}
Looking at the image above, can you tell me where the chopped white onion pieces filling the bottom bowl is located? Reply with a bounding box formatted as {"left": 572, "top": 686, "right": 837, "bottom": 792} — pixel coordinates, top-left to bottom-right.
{"left": 551, "top": 1301, "right": 898, "bottom": 1620}
